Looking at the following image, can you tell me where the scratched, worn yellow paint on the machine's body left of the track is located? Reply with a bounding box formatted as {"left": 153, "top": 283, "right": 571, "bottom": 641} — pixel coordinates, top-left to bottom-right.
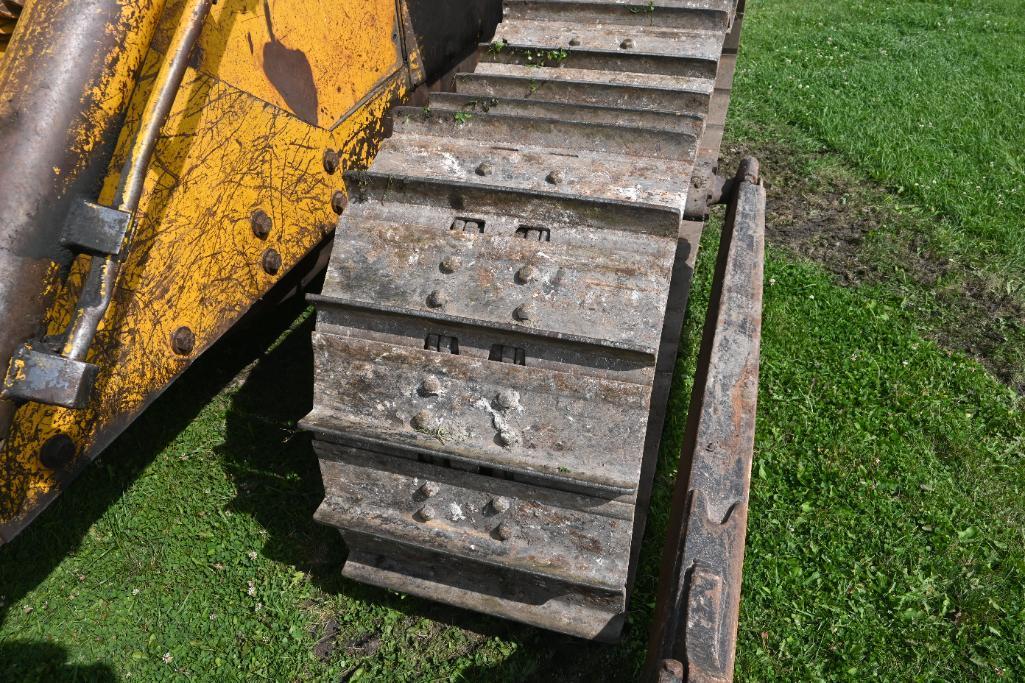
{"left": 0, "top": 0, "right": 410, "bottom": 541}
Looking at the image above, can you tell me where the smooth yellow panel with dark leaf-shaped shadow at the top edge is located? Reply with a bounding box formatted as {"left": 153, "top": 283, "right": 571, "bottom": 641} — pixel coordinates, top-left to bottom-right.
{"left": 193, "top": 0, "right": 402, "bottom": 128}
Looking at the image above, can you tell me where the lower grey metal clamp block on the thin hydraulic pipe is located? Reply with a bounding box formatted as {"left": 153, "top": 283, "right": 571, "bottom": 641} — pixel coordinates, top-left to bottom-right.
{"left": 0, "top": 345, "right": 98, "bottom": 408}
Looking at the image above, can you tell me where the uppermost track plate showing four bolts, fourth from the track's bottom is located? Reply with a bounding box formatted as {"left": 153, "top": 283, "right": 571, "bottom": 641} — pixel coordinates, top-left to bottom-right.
{"left": 315, "top": 207, "right": 672, "bottom": 348}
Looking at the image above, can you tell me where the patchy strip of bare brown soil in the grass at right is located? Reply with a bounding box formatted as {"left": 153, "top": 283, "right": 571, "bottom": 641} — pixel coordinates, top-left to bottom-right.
{"left": 721, "top": 140, "right": 1025, "bottom": 394}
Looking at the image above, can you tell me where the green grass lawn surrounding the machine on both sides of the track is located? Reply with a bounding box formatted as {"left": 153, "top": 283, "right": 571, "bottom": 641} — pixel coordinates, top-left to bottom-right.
{"left": 0, "top": 0, "right": 1025, "bottom": 681}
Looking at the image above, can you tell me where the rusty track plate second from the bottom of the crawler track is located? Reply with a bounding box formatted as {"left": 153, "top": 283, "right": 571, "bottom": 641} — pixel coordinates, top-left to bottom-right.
{"left": 317, "top": 445, "right": 630, "bottom": 593}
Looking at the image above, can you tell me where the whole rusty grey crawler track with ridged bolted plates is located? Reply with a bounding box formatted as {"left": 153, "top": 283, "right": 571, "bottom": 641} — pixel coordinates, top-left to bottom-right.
{"left": 303, "top": 0, "right": 758, "bottom": 640}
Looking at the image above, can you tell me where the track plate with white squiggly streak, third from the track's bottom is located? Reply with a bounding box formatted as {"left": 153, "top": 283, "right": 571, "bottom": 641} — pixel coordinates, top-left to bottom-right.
{"left": 303, "top": 332, "right": 648, "bottom": 497}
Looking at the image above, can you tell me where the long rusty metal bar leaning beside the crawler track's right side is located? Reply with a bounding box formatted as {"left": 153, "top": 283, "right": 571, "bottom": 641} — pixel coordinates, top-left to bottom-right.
{"left": 646, "top": 160, "right": 765, "bottom": 681}
